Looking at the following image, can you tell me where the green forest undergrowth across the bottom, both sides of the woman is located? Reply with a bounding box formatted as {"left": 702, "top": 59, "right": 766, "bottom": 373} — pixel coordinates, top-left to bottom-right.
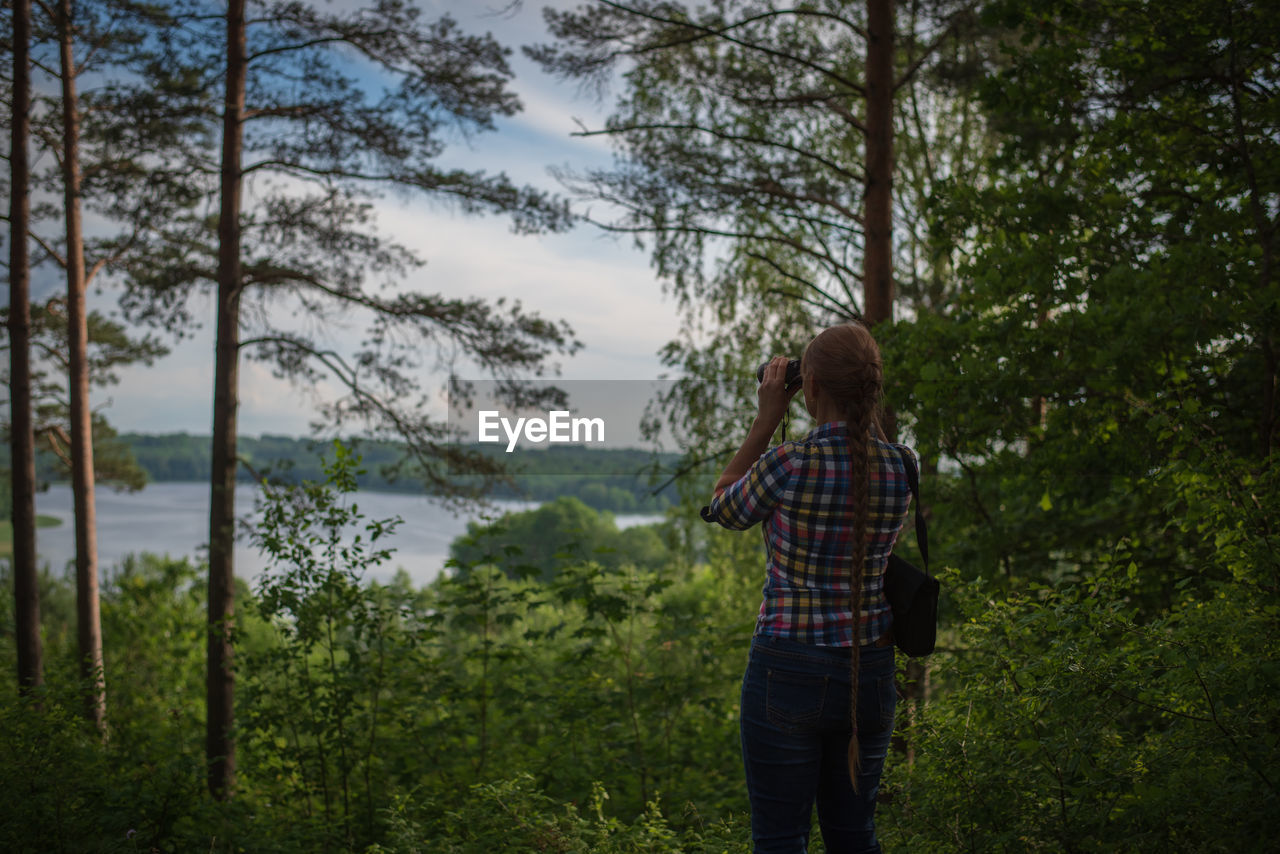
{"left": 0, "top": 437, "right": 1280, "bottom": 854}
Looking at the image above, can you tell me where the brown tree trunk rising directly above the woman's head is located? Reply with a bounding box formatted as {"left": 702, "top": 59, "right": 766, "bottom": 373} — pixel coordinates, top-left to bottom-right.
{"left": 863, "top": 0, "right": 893, "bottom": 326}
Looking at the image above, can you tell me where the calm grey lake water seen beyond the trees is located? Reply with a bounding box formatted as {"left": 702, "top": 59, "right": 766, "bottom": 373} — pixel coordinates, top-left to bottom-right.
{"left": 36, "top": 483, "right": 662, "bottom": 586}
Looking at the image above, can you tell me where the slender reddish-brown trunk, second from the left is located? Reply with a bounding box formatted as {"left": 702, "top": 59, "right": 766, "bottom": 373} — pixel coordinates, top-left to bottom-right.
{"left": 58, "top": 0, "right": 106, "bottom": 734}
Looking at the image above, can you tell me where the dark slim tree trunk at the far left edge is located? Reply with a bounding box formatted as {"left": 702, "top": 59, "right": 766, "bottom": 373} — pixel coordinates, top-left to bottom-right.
{"left": 9, "top": 0, "right": 45, "bottom": 691}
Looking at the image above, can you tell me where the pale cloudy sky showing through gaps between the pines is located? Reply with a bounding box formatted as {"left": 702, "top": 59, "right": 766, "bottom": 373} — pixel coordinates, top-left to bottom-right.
{"left": 71, "top": 0, "right": 678, "bottom": 435}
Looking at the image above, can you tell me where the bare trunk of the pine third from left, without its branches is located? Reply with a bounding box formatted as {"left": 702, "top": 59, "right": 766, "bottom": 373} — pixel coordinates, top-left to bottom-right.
{"left": 205, "top": 0, "right": 248, "bottom": 799}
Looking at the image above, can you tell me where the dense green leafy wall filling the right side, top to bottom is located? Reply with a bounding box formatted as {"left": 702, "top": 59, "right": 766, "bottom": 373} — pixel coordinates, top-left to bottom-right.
{"left": 882, "top": 0, "right": 1280, "bottom": 851}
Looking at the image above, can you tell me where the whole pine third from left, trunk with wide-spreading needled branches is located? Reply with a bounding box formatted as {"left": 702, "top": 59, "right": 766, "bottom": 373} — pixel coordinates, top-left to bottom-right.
{"left": 116, "top": 0, "right": 576, "bottom": 796}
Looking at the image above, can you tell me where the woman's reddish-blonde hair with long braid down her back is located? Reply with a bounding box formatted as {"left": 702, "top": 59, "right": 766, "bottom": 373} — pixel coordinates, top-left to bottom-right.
{"left": 801, "top": 323, "right": 884, "bottom": 791}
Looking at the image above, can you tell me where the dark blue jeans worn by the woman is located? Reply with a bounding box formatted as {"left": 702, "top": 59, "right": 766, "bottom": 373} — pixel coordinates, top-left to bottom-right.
{"left": 740, "top": 635, "right": 897, "bottom": 854}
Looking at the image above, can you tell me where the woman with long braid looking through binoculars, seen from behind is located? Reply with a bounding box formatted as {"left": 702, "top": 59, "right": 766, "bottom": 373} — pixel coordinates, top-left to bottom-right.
{"left": 703, "top": 324, "right": 914, "bottom": 854}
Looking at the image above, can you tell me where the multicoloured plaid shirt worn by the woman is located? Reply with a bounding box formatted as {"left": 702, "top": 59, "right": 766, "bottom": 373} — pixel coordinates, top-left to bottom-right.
{"left": 703, "top": 421, "right": 915, "bottom": 647}
